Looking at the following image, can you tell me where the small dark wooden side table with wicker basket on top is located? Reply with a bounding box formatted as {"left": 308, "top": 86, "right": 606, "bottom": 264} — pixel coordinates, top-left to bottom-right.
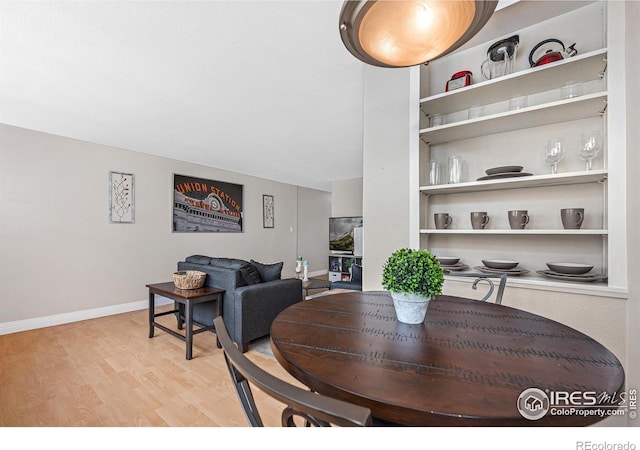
{"left": 147, "top": 281, "right": 225, "bottom": 359}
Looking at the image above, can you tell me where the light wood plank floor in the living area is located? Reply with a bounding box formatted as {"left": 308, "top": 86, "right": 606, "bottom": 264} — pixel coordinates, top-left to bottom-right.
{"left": 0, "top": 304, "right": 300, "bottom": 427}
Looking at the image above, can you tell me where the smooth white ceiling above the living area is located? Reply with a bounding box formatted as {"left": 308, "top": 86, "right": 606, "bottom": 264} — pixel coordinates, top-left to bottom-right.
{"left": 0, "top": 0, "right": 510, "bottom": 191}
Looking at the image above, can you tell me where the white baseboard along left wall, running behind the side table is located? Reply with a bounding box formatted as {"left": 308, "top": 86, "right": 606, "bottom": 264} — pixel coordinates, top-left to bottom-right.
{"left": 0, "top": 295, "right": 173, "bottom": 335}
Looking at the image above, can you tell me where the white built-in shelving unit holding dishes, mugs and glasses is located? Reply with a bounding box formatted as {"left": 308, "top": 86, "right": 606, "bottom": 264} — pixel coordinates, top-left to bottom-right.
{"left": 419, "top": 0, "right": 626, "bottom": 296}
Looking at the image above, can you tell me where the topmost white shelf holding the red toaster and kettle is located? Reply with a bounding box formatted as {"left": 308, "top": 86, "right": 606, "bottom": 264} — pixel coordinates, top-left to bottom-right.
{"left": 420, "top": 48, "right": 607, "bottom": 114}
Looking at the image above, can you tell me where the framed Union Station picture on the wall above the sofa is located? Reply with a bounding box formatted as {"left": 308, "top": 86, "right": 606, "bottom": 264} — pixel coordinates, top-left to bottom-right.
{"left": 173, "top": 174, "right": 244, "bottom": 233}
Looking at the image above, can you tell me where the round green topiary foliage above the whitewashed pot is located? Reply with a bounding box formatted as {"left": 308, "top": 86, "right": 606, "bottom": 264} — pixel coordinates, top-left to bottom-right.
{"left": 382, "top": 248, "right": 444, "bottom": 299}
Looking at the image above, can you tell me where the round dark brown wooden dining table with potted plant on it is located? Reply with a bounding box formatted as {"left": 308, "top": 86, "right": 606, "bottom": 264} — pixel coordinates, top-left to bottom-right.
{"left": 271, "top": 291, "right": 625, "bottom": 426}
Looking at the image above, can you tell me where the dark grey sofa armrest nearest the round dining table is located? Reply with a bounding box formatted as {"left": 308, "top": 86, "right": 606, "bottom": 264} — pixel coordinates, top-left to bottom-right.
{"left": 234, "top": 278, "right": 302, "bottom": 344}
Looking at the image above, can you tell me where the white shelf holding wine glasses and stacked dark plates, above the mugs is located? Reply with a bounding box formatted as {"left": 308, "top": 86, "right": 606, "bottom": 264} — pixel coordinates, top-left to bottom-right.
{"left": 420, "top": 169, "right": 608, "bottom": 195}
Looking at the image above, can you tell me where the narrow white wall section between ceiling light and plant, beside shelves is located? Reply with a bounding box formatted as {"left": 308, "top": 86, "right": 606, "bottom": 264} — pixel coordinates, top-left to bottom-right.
{"left": 362, "top": 66, "right": 420, "bottom": 290}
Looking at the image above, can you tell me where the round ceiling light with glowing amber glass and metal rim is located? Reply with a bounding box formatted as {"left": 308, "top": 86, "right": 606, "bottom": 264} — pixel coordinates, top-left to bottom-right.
{"left": 339, "top": 0, "right": 498, "bottom": 67}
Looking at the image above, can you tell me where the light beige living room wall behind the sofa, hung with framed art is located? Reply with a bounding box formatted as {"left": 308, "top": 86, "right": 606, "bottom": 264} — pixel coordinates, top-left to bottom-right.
{"left": 0, "top": 125, "right": 330, "bottom": 333}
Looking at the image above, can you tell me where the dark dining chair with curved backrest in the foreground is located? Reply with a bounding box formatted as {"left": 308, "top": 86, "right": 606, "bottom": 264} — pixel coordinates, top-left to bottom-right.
{"left": 213, "top": 316, "right": 372, "bottom": 427}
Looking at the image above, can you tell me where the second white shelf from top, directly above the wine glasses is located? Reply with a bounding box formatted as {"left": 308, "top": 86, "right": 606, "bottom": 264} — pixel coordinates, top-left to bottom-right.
{"left": 420, "top": 92, "right": 607, "bottom": 145}
